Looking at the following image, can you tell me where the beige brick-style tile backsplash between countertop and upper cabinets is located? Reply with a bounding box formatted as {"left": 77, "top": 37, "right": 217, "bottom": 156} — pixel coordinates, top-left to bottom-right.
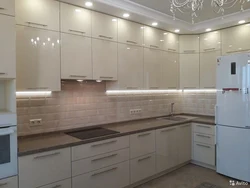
{"left": 17, "top": 81, "right": 216, "bottom": 136}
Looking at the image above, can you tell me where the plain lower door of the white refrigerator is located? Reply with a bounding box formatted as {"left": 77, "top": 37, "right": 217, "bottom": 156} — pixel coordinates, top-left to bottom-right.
{"left": 217, "top": 125, "right": 250, "bottom": 182}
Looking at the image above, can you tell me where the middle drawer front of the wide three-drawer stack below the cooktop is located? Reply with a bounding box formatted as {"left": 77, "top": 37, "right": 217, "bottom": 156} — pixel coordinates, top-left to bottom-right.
{"left": 72, "top": 148, "right": 129, "bottom": 176}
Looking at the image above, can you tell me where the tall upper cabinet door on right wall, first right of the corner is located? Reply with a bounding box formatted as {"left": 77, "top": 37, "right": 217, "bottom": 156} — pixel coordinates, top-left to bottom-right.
{"left": 180, "top": 54, "right": 200, "bottom": 89}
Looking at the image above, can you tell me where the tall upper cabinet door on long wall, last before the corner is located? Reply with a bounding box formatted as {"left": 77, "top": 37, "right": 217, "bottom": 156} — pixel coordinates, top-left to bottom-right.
{"left": 161, "top": 52, "right": 180, "bottom": 89}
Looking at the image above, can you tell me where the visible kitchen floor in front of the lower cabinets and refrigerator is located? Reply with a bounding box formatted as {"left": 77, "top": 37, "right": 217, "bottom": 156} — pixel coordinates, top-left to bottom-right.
{"left": 137, "top": 164, "right": 247, "bottom": 188}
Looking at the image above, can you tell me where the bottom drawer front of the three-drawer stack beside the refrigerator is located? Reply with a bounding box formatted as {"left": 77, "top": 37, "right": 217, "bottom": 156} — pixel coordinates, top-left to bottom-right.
{"left": 193, "top": 142, "right": 215, "bottom": 166}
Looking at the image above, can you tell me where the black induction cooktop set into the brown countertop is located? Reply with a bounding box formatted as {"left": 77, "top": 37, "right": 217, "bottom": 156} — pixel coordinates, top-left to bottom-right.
{"left": 66, "top": 127, "right": 119, "bottom": 140}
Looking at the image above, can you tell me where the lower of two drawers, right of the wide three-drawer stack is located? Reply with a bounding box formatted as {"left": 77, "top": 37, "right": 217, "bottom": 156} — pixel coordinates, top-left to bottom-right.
{"left": 130, "top": 153, "right": 156, "bottom": 184}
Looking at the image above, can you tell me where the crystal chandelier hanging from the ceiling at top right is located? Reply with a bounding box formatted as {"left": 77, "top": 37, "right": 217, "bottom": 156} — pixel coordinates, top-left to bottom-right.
{"left": 170, "top": 0, "right": 246, "bottom": 23}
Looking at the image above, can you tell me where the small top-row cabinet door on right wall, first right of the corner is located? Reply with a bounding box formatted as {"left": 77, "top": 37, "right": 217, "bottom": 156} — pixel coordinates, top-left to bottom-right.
{"left": 180, "top": 35, "right": 200, "bottom": 53}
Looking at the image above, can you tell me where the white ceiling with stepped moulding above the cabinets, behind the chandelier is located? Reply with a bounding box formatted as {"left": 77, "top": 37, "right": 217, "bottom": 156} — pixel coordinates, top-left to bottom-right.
{"left": 61, "top": 0, "right": 250, "bottom": 34}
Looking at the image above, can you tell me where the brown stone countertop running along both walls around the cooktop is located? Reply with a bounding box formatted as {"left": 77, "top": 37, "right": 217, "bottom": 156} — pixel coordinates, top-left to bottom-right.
{"left": 18, "top": 115, "right": 215, "bottom": 156}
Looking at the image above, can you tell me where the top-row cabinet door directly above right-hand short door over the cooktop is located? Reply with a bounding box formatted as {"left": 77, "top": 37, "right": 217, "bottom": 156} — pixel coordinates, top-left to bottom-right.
{"left": 92, "top": 12, "right": 118, "bottom": 41}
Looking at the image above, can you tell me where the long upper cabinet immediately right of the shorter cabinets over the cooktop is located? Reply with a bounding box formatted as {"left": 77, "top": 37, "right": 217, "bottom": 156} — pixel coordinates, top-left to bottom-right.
{"left": 106, "top": 44, "right": 143, "bottom": 90}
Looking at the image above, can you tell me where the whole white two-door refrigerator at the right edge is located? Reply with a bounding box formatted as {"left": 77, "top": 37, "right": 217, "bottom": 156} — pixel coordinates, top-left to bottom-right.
{"left": 215, "top": 53, "right": 250, "bottom": 182}
